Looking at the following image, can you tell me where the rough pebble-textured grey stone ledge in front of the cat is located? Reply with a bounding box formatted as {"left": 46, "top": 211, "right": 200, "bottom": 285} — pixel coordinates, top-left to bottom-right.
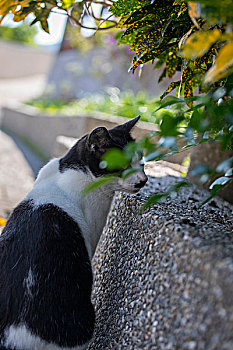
{"left": 89, "top": 176, "right": 233, "bottom": 350}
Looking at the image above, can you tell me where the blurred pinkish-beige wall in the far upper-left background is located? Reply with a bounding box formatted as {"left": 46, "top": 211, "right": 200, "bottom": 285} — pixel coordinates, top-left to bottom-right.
{"left": 0, "top": 40, "right": 55, "bottom": 79}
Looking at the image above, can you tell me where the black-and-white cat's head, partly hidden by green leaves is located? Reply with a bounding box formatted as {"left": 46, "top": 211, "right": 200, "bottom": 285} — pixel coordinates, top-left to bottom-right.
{"left": 60, "top": 116, "right": 147, "bottom": 193}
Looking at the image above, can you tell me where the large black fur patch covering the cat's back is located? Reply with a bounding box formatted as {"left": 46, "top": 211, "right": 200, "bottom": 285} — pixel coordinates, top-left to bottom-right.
{"left": 0, "top": 201, "right": 95, "bottom": 347}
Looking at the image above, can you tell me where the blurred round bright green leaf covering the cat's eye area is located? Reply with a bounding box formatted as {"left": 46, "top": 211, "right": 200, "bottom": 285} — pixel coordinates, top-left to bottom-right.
{"left": 102, "top": 148, "right": 130, "bottom": 171}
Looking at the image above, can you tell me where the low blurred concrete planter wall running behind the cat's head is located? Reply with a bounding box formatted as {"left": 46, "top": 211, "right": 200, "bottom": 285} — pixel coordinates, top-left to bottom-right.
{"left": 0, "top": 107, "right": 156, "bottom": 158}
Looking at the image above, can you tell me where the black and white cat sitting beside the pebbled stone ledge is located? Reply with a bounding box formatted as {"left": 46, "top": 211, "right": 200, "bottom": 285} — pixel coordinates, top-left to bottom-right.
{"left": 0, "top": 117, "right": 147, "bottom": 350}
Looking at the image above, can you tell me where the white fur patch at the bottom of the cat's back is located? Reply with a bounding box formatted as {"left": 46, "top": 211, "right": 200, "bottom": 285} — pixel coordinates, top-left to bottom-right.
{"left": 3, "top": 325, "right": 88, "bottom": 350}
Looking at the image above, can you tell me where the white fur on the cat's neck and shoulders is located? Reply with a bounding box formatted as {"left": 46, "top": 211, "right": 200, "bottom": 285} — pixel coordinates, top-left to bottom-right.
{"left": 28, "top": 159, "right": 114, "bottom": 257}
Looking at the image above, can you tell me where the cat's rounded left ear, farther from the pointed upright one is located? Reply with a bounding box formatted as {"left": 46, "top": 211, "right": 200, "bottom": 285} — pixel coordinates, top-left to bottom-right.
{"left": 87, "top": 127, "right": 111, "bottom": 150}
